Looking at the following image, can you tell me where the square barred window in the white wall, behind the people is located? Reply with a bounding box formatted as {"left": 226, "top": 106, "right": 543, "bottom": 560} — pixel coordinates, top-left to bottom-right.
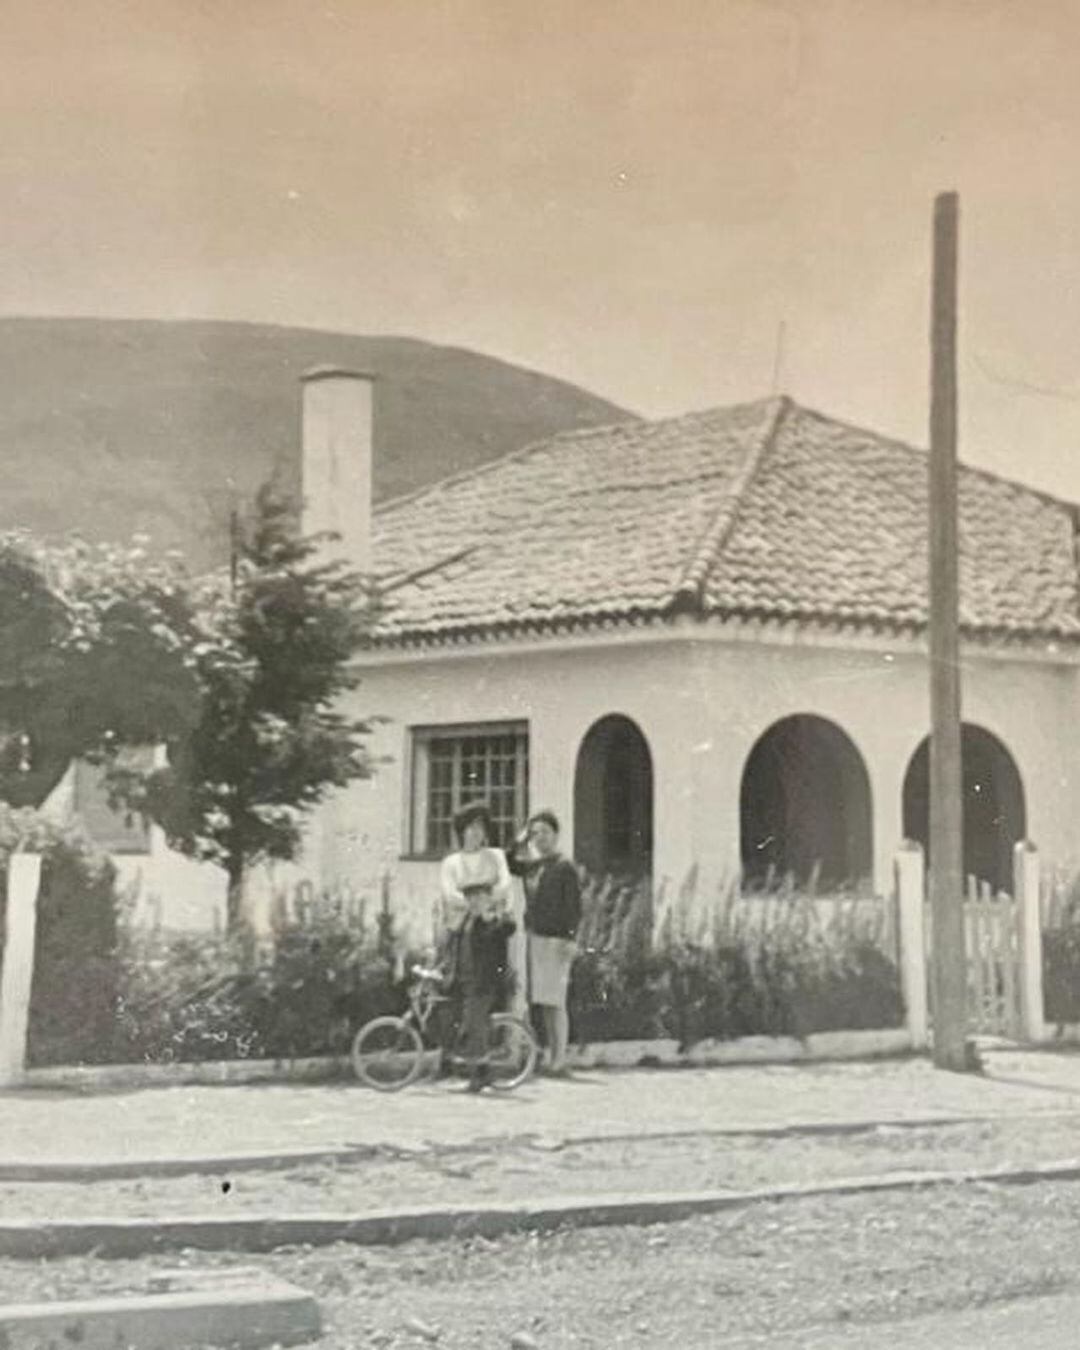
{"left": 409, "top": 722, "right": 529, "bottom": 857}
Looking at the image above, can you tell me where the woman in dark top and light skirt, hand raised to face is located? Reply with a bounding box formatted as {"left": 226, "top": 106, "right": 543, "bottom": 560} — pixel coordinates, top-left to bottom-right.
{"left": 510, "top": 811, "right": 582, "bottom": 1077}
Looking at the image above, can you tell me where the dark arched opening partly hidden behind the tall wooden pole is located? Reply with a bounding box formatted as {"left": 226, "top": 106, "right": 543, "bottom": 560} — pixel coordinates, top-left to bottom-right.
{"left": 903, "top": 722, "right": 1027, "bottom": 892}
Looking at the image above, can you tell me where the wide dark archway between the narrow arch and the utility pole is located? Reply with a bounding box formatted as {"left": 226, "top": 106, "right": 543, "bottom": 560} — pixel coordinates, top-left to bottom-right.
{"left": 738, "top": 714, "right": 873, "bottom": 888}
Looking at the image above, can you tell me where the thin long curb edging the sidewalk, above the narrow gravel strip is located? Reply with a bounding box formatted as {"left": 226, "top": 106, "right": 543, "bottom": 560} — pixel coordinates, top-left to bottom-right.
{"left": 0, "top": 1108, "right": 1063, "bottom": 1185}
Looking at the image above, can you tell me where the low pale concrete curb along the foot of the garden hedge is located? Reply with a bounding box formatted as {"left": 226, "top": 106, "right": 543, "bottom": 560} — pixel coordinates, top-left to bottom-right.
{"left": 15, "top": 1027, "right": 914, "bottom": 1092}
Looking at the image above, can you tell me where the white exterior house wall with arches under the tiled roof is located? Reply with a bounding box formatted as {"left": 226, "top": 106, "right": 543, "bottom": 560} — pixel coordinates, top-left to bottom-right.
{"left": 320, "top": 628, "right": 1080, "bottom": 936}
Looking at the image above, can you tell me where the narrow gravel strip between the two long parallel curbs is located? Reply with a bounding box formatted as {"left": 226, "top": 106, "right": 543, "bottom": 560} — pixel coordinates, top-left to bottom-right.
{"left": 0, "top": 1115, "right": 1080, "bottom": 1219}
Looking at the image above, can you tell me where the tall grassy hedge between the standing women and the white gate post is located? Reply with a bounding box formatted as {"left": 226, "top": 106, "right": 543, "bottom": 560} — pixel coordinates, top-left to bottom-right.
{"left": 571, "top": 876, "right": 903, "bottom": 1048}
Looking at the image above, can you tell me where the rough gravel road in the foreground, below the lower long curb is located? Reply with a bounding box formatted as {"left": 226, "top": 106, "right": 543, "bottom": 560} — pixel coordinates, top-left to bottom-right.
{"left": 0, "top": 1184, "right": 1080, "bottom": 1350}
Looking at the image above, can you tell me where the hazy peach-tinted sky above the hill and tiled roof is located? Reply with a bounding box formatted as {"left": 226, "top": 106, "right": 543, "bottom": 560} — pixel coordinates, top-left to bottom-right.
{"left": 0, "top": 0, "right": 1080, "bottom": 498}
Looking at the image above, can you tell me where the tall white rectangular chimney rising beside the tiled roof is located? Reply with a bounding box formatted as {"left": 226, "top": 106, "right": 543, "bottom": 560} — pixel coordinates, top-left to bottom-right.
{"left": 301, "top": 366, "right": 374, "bottom": 572}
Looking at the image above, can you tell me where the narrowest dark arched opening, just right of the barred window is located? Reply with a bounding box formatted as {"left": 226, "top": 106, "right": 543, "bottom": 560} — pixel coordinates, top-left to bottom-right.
{"left": 574, "top": 714, "right": 652, "bottom": 879}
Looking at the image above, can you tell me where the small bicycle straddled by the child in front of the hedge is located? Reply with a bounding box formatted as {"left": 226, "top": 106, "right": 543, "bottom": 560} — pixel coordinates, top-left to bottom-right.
{"left": 351, "top": 965, "right": 540, "bottom": 1092}
